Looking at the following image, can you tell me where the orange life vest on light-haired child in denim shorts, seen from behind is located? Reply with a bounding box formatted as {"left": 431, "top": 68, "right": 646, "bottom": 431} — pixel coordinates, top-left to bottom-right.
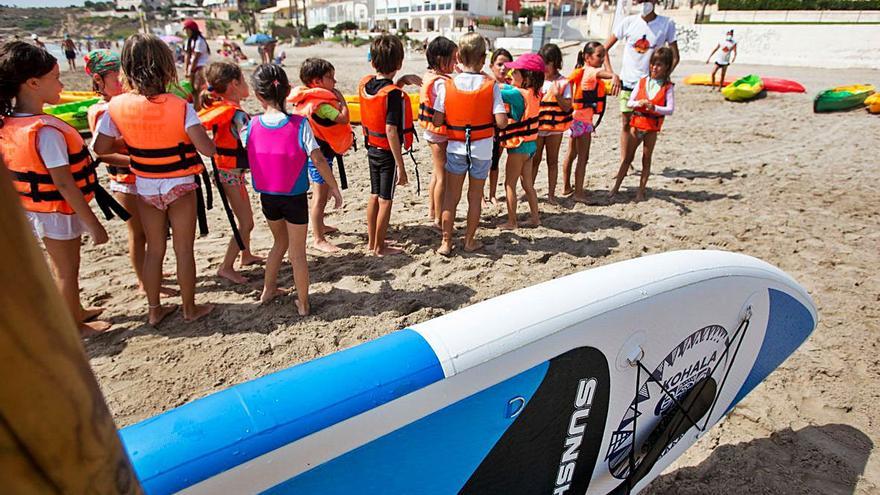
{"left": 444, "top": 77, "right": 495, "bottom": 143}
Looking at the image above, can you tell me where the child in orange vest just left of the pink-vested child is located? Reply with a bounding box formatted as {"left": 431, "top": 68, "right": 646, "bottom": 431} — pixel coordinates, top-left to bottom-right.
{"left": 199, "top": 62, "right": 263, "bottom": 284}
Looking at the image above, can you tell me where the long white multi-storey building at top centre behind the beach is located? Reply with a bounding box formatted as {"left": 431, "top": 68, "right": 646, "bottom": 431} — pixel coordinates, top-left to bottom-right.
{"left": 374, "top": 0, "right": 505, "bottom": 31}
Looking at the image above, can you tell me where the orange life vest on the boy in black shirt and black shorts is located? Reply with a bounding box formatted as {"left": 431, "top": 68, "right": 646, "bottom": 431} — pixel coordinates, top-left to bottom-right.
{"left": 358, "top": 75, "right": 415, "bottom": 150}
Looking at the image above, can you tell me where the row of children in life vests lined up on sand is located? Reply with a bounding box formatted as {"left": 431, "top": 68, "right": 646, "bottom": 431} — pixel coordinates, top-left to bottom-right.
{"left": 0, "top": 33, "right": 671, "bottom": 336}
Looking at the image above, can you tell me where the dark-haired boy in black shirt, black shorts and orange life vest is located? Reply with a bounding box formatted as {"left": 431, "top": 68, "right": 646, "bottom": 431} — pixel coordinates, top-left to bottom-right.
{"left": 358, "top": 34, "right": 422, "bottom": 256}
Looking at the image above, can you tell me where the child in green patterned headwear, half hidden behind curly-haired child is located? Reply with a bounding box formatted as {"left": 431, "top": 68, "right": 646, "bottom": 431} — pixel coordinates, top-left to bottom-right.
{"left": 84, "top": 49, "right": 177, "bottom": 295}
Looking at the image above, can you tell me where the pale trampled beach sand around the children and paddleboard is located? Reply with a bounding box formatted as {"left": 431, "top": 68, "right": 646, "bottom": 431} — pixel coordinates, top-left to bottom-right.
{"left": 58, "top": 45, "right": 880, "bottom": 494}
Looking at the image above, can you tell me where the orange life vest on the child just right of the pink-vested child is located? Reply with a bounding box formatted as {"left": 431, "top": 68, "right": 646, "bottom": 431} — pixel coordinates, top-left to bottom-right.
{"left": 287, "top": 86, "right": 354, "bottom": 156}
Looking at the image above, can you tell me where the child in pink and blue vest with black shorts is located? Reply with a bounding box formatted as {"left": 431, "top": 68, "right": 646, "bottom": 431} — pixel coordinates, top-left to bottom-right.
{"left": 242, "top": 64, "right": 342, "bottom": 316}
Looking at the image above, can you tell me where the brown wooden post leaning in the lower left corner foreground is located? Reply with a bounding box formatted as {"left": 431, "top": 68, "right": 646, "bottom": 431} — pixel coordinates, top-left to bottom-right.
{"left": 0, "top": 164, "right": 142, "bottom": 494}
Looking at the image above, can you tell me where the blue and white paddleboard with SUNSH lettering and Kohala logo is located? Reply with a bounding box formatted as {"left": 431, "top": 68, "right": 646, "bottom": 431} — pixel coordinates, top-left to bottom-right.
{"left": 121, "top": 251, "right": 817, "bottom": 495}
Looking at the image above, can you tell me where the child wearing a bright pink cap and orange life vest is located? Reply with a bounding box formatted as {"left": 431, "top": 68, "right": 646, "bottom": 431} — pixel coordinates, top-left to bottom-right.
{"left": 498, "top": 53, "right": 544, "bottom": 230}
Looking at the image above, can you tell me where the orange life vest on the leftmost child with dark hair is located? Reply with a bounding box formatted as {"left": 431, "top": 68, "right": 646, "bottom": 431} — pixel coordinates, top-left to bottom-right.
{"left": 0, "top": 114, "right": 100, "bottom": 215}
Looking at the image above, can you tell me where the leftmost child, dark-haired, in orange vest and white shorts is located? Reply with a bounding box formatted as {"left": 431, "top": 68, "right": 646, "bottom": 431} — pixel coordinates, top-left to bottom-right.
{"left": 0, "top": 41, "right": 110, "bottom": 337}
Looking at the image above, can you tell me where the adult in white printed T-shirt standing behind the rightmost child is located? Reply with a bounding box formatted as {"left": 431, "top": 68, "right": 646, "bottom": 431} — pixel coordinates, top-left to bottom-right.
{"left": 605, "top": 0, "right": 679, "bottom": 174}
